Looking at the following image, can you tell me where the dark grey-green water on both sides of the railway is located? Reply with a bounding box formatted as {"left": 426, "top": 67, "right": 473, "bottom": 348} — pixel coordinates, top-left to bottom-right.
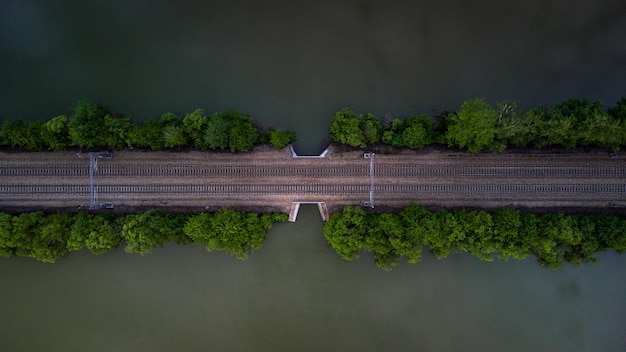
{"left": 0, "top": 0, "right": 626, "bottom": 351}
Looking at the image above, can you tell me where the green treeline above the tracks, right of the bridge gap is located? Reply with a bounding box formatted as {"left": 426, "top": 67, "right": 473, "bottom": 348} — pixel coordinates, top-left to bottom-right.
{"left": 328, "top": 97, "right": 626, "bottom": 153}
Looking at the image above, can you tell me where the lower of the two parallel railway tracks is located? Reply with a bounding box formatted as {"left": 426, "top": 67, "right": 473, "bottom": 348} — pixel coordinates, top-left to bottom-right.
{"left": 0, "top": 183, "right": 626, "bottom": 199}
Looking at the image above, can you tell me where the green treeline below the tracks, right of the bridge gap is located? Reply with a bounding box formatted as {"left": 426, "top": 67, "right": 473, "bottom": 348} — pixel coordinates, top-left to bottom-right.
{"left": 324, "top": 204, "right": 626, "bottom": 269}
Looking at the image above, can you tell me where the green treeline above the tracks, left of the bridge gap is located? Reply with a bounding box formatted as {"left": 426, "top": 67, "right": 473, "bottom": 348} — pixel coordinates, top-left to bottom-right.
{"left": 0, "top": 100, "right": 296, "bottom": 152}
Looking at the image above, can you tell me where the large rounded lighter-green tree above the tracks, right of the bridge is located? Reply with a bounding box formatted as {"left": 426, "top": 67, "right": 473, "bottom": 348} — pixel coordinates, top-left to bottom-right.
{"left": 445, "top": 99, "right": 505, "bottom": 153}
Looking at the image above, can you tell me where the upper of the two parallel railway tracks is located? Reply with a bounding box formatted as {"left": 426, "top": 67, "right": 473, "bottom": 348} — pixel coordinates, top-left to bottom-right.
{"left": 0, "top": 163, "right": 626, "bottom": 178}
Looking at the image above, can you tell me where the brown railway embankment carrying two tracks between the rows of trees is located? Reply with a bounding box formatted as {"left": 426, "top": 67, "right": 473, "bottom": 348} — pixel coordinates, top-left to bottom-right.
{"left": 0, "top": 148, "right": 626, "bottom": 214}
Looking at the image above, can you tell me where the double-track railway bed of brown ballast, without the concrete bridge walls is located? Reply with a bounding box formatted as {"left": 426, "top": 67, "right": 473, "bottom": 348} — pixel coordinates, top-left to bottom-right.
{"left": 0, "top": 153, "right": 626, "bottom": 214}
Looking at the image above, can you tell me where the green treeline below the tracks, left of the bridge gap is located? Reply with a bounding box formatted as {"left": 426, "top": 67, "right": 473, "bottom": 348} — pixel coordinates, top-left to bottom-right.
{"left": 0, "top": 209, "right": 287, "bottom": 263}
